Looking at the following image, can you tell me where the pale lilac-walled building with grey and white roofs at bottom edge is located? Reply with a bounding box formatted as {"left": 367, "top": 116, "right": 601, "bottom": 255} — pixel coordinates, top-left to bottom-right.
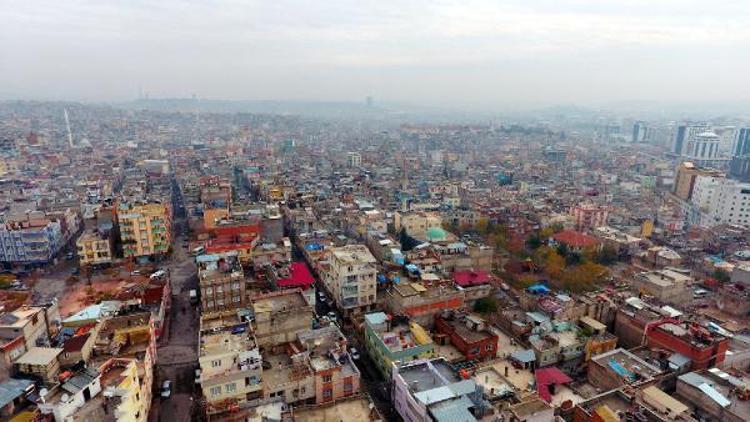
{"left": 391, "top": 358, "right": 490, "bottom": 422}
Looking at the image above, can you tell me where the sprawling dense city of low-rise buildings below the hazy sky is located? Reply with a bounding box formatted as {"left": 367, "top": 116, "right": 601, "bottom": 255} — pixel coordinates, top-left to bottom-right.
{"left": 0, "top": 98, "right": 750, "bottom": 422}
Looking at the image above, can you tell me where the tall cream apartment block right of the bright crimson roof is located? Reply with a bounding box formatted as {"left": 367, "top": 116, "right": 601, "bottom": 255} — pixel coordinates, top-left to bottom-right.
{"left": 322, "top": 245, "right": 377, "bottom": 316}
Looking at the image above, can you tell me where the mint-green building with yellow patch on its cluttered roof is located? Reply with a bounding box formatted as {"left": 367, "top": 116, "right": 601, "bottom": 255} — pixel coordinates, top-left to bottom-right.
{"left": 365, "top": 312, "right": 434, "bottom": 379}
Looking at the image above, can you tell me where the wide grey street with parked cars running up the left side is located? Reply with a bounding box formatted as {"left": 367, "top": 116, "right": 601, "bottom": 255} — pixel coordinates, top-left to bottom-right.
{"left": 149, "top": 223, "right": 199, "bottom": 422}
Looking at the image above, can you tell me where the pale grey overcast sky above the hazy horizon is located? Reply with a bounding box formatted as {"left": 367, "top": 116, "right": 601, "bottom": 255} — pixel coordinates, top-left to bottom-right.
{"left": 0, "top": 0, "right": 750, "bottom": 108}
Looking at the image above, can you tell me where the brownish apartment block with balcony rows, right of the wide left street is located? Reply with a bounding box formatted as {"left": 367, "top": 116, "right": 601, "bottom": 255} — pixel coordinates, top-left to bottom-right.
{"left": 196, "top": 252, "right": 247, "bottom": 312}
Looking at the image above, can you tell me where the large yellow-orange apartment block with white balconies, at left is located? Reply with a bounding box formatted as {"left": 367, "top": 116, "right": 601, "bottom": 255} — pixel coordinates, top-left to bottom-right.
{"left": 117, "top": 203, "right": 172, "bottom": 258}
